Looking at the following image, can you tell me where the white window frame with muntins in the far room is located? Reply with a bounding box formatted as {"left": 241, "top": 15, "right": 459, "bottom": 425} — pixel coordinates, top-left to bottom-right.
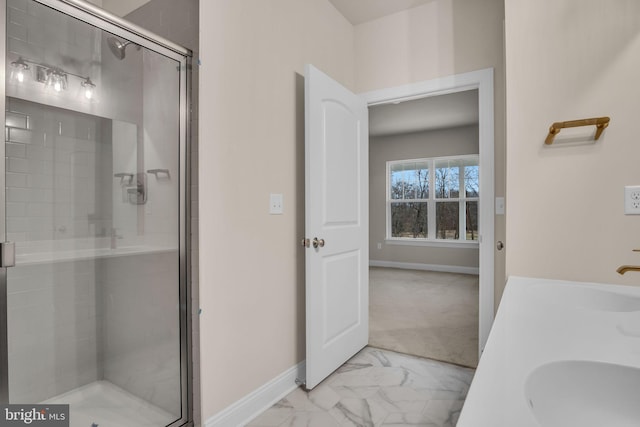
{"left": 385, "top": 154, "right": 481, "bottom": 248}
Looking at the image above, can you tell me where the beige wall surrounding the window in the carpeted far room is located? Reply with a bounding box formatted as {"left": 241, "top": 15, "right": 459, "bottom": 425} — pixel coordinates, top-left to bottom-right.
{"left": 369, "top": 125, "right": 478, "bottom": 268}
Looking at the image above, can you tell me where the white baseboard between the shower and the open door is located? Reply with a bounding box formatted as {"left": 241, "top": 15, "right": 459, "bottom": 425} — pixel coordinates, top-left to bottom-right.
{"left": 204, "top": 361, "right": 305, "bottom": 427}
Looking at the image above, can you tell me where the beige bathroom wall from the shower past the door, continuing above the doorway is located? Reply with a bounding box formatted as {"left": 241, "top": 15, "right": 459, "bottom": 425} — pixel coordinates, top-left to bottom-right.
{"left": 199, "top": 0, "right": 504, "bottom": 420}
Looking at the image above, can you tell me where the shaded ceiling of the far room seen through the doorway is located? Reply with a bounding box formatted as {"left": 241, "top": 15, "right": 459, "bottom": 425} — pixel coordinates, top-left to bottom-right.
{"left": 369, "top": 89, "right": 478, "bottom": 136}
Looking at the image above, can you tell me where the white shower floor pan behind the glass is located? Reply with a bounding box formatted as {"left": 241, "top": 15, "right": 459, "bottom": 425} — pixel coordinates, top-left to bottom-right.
{"left": 42, "top": 381, "right": 179, "bottom": 427}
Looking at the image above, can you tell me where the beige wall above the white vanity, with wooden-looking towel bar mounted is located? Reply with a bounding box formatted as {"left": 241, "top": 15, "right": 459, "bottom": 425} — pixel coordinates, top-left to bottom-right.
{"left": 506, "top": 0, "right": 640, "bottom": 285}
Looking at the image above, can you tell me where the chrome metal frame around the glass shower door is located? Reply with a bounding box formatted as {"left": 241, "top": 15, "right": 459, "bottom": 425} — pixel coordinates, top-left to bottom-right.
{"left": 0, "top": 0, "right": 193, "bottom": 427}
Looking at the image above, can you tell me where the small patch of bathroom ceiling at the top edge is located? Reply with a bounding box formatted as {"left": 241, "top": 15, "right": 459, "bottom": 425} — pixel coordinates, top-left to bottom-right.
{"left": 329, "top": 0, "right": 433, "bottom": 25}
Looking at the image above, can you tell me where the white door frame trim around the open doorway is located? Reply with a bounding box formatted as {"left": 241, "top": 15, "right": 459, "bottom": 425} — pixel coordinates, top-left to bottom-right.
{"left": 360, "top": 68, "right": 495, "bottom": 355}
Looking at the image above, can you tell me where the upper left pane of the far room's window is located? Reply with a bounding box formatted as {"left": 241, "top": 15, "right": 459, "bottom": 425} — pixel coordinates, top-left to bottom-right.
{"left": 389, "top": 162, "right": 429, "bottom": 200}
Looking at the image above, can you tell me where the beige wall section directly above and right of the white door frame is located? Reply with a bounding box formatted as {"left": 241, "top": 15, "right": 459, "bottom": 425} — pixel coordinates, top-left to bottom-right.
{"left": 355, "top": 0, "right": 506, "bottom": 307}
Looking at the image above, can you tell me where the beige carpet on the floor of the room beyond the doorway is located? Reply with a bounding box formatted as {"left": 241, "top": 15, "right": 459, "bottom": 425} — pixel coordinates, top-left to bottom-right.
{"left": 369, "top": 267, "right": 478, "bottom": 368}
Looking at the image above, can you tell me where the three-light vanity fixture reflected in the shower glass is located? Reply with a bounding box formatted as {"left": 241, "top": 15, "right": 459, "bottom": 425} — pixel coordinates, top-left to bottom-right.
{"left": 11, "top": 57, "right": 96, "bottom": 99}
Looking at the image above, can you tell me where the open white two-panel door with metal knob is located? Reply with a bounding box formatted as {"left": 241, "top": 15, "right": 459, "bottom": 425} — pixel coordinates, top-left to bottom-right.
{"left": 305, "top": 65, "right": 369, "bottom": 389}
